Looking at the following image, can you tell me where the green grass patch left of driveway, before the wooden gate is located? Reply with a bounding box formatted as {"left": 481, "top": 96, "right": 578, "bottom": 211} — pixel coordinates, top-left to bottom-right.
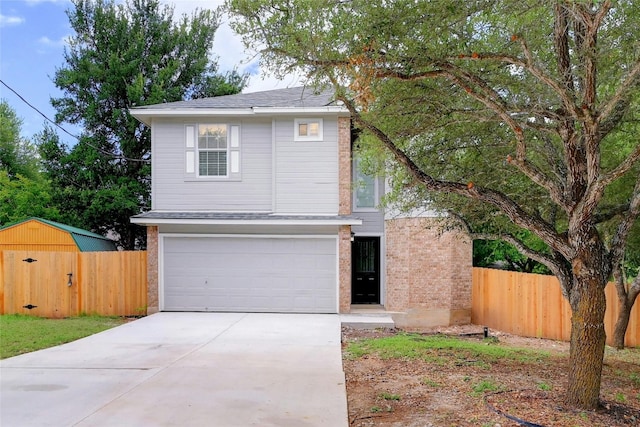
{"left": 0, "top": 314, "right": 126, "bottom": 359}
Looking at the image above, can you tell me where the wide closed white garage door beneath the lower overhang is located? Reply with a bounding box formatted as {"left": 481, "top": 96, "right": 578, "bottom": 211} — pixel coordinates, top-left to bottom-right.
{"left": 163, "top": 237, "right": 337, "bottom": 313}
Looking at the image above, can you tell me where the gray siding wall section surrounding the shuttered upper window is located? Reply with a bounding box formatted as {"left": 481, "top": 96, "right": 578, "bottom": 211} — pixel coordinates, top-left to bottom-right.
{"left": 152, "top": 117, "right": 273, "bottom": 211}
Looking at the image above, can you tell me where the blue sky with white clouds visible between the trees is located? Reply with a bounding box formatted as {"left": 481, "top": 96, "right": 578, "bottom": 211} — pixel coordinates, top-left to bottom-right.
{"left": 0, "top": 0, "right": 301, "bottom": 144}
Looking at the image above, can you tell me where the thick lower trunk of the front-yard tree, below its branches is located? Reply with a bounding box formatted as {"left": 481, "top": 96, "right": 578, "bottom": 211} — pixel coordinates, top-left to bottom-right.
{"left": 565, "top": 277, "right": 607, "bottom": 410}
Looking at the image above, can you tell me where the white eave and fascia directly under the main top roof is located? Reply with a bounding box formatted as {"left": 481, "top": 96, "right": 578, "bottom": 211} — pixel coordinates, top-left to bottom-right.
{"left": 129, "top": 106, "right": 350, "bottom": 125}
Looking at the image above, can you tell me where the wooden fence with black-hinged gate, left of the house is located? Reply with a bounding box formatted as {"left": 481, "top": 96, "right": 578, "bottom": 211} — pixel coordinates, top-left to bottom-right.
{"left": 0, "top": 251, "right": 147, "bottom": 318}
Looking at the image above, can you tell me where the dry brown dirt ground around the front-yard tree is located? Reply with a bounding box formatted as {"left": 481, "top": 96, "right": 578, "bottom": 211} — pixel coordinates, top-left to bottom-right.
{"left": 342, "top": 325, "right": 640, "bottom": 427}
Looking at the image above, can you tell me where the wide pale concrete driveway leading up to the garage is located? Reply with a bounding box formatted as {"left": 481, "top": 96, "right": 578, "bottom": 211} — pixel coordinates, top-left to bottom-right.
{"left": 0, "top": 313, "right": 348, "bottom": 427}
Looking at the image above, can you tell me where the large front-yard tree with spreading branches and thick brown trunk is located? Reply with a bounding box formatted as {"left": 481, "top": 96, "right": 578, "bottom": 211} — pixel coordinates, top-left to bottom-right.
{"left": 228, "top": 0, "right": 640, "bottom": 408}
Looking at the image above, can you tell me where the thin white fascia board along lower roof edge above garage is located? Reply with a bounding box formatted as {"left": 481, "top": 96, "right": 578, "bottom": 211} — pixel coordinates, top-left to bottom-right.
{"left": 130, "top": 218, "right": 362, "bottom": 226}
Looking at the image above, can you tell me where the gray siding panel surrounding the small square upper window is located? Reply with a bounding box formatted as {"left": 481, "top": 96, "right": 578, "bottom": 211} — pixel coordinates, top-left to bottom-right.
{"left": 274, "top": 117, "right": 338, "bottom": 214}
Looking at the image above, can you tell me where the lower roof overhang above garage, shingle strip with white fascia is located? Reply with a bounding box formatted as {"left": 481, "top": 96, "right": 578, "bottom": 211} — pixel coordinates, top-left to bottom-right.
{"left": 130, "top": 211, "right": 362, "bottom": 226}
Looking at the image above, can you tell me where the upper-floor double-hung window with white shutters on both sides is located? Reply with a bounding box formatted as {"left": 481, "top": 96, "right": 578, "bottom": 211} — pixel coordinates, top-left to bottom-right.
{"left": 185, "top": 123, "right": 240, "bottom": 179}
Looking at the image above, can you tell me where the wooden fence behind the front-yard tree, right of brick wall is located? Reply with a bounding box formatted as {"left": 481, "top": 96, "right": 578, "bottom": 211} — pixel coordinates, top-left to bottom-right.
{"left": 471, "top": 268, "right": 640, "bottom": 347}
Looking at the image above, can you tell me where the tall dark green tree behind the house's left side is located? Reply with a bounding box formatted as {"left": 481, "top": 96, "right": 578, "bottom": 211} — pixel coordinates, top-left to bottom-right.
{"left": 41, "top": 0, "right": 246, "bottom": 249}
